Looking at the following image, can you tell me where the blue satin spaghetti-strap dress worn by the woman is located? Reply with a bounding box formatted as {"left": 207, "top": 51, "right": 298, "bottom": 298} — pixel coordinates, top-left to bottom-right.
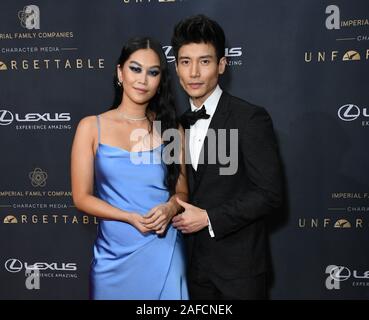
{"left": 90, "top": 116, "right": 188, "bottom": 300}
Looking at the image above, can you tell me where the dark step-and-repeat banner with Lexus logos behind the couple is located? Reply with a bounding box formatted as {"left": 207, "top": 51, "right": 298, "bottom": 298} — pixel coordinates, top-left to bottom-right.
{"left": 0, "top": 0, "right": 369, "bottom": 299}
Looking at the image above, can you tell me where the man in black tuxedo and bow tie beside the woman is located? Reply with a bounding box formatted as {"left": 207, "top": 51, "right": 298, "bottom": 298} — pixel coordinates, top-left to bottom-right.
{"left": 172, "top": 15, "right": 282, "bottom": 300}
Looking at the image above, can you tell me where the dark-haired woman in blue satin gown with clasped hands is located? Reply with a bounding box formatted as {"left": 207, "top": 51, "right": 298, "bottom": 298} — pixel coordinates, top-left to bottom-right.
{"left": 71, "top": 38, "right": 188, "bottom": 300}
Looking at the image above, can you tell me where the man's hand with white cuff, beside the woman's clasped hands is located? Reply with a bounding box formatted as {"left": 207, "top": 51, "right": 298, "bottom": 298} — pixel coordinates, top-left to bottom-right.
{"left": 172, "top": 198, "right": 209, "bottom": 233}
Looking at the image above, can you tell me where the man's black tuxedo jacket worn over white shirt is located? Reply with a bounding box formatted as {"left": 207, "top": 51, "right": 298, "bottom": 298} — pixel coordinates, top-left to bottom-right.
{"left": 182, "top": 92, "right": 282, "bottom": 279}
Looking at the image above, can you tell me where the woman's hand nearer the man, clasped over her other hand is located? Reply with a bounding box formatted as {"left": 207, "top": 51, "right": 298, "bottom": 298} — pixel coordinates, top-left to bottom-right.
{"left": 143, "top": 202, "right": 176, "bottom": 235}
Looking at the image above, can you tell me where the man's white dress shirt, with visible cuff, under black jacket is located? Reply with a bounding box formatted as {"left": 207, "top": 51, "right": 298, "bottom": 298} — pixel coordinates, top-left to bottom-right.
{"left": 189, "top": 85, "right": 223, "bottom": 238}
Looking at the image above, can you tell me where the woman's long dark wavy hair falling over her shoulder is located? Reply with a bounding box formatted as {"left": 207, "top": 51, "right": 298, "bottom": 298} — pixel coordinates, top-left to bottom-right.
{"left": 111, "top": 37, "right": 180, "bottom": 195}
